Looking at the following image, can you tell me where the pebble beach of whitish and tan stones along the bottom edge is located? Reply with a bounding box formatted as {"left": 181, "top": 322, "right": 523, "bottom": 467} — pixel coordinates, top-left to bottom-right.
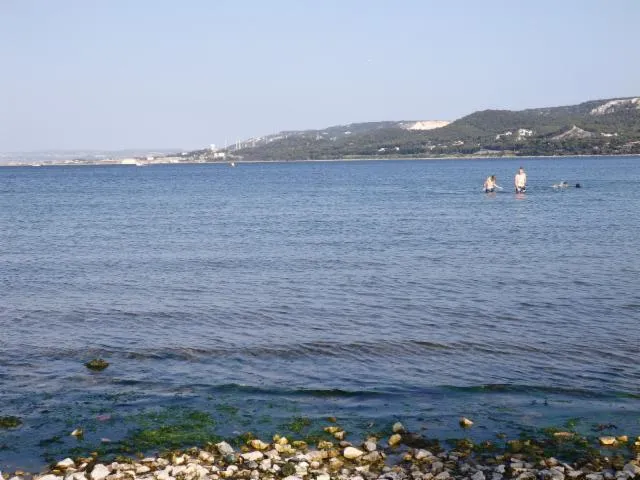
{"left": 2, "top": 418, "right": 640, "bottom": 480}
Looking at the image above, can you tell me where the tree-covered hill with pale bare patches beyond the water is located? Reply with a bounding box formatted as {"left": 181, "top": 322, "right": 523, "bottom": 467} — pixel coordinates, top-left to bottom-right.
{"left": 180, "top": 97, "right": 640, "bottom": 161}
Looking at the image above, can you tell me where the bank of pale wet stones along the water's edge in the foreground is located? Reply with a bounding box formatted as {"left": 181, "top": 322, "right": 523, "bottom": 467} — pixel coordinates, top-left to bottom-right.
{"left": 3, "top": 428, "right": 640, "bottom": 480}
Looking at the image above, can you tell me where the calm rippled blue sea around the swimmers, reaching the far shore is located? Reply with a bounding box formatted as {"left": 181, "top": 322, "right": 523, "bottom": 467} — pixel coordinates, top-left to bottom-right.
{"left": 0, "top": 158, "right": 640, "bottom": 469}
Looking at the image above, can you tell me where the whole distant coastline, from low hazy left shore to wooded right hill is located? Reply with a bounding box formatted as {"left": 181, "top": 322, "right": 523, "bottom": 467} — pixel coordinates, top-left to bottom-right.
{"left": 0, "top": 96, "right": 640, "bottom": 166}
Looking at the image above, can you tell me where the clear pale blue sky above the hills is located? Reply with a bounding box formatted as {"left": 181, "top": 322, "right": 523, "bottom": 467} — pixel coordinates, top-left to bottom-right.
{"left": 0, "top": 0, "right": 640, "bottom": 152}
